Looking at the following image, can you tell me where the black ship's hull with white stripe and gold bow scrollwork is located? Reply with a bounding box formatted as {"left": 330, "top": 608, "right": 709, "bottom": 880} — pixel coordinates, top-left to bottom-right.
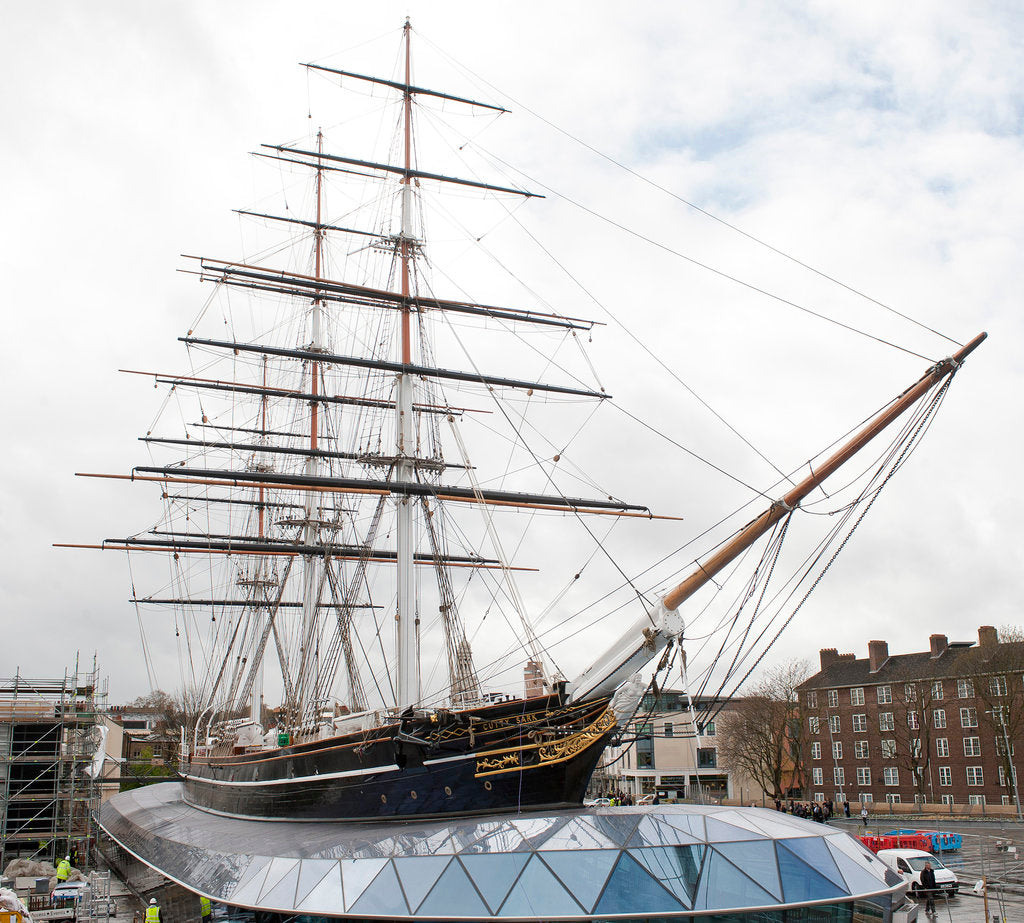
{"left": 182, "top": 696, "right": 615, "bottom": 821}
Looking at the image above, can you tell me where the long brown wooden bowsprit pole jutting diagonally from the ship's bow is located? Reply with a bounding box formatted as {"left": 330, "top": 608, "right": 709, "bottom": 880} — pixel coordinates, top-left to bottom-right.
{"left": 663, "top": 333, "right": 988, "bottom": 612}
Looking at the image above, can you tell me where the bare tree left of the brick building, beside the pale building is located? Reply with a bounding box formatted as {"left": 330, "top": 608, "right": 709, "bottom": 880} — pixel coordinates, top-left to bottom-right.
{"left": 719, "top": 660, "right": 811, "bottom": 798}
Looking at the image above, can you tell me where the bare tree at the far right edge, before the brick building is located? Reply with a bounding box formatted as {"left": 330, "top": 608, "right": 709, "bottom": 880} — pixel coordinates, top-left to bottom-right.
{"left": 956, "top": 625, "right": 1024, "bottom": 798}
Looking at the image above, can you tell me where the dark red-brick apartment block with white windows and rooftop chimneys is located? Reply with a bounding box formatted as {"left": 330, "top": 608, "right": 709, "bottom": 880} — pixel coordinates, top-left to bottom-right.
{"left": 799, "top": 626, "right": 1024, "bottom": 805}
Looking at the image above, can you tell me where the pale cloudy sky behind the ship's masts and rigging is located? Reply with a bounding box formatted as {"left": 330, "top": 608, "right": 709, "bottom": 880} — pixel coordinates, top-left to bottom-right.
{"left": 0, "top": 0, "right": 1024, "bottom": 702}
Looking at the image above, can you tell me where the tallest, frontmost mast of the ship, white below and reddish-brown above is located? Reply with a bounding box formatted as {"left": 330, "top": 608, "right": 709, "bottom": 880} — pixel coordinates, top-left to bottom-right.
{"left": 395, "top": 18, "right": 420, "bottom": 710}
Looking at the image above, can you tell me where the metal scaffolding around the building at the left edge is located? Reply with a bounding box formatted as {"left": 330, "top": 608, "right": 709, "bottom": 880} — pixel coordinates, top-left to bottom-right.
{"left": 0, "top": 659, "right": 106, "bottom": 869}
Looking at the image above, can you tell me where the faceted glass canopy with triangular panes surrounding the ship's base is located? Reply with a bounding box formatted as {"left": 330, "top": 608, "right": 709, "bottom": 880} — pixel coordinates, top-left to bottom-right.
{"left": 100, "top": 783, "right": 905, "bottom": 921}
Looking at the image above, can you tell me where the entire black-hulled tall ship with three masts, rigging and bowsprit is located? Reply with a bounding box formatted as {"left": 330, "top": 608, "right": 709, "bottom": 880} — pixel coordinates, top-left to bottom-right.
{"left": 70, "top": 23, "right": 984, "bottom": 821}
